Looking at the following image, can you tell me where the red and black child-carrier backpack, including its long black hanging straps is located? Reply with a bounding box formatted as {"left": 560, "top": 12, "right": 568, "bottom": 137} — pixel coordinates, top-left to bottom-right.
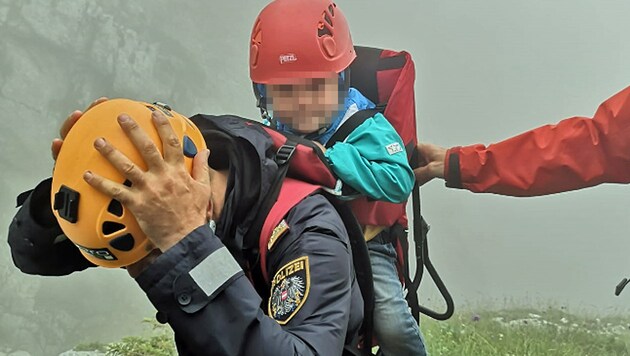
{"left": 239, "top": 46, "right": 454, "bottom": 354}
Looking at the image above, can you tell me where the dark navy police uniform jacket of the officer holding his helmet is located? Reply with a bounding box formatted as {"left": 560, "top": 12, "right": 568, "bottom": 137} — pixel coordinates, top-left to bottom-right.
{"left": 9, "top": 117, "right": 363, "bottom": 355}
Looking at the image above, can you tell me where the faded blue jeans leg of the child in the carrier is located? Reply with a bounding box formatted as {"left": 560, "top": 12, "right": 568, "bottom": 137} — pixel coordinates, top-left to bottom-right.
{"left": 367, "top": 236, "right": 427, "bottom": 356}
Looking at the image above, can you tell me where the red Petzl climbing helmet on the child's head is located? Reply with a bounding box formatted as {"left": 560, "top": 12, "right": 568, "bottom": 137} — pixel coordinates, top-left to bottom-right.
{"left": 249, "top": 0, "right": 356, "bottom": 84}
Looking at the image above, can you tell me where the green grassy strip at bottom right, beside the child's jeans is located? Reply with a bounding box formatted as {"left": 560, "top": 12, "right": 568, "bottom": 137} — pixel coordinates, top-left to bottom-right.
{"left": 421, "top": 308, "right": 630, "bottom": 356}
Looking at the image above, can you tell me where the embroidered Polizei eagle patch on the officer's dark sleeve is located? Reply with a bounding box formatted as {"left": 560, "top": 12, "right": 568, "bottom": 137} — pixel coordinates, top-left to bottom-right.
{"left": 267, "top": 256, "right": 311, "bottom": 325}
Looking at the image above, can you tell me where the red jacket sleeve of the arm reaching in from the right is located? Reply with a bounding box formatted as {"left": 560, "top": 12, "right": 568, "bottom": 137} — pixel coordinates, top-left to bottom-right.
{"left": 444, "top": 87, "right": 630, "bottom": 196}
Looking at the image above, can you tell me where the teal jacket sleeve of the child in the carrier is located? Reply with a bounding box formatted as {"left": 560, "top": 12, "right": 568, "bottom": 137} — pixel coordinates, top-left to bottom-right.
{"left": 325, "top": 113, "right": 415, "bottom": 203}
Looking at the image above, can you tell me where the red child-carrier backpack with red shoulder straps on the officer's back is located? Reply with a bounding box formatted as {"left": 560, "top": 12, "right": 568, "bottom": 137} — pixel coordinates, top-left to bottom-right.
{"left": 254, "top": 46, "right": 454, "bottom": 320}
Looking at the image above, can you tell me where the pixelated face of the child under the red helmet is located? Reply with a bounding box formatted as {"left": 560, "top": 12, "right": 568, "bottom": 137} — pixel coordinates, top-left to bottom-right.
{"left": 267, "top": 74, "right": 345, "bottom": 133}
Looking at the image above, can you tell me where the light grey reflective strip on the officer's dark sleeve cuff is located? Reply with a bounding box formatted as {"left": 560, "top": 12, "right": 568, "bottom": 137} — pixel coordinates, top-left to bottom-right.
{"left": 189, "top": 246, "right": 241, "bottom": 297}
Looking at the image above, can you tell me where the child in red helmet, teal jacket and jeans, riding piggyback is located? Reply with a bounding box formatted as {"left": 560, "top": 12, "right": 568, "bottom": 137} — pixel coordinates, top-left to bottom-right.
{"left": 249, "top": 0, "right": 426, "bottom": 355}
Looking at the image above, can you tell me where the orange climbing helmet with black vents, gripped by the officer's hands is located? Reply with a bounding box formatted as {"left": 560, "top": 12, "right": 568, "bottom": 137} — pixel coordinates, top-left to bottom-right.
{"left": 51, "top": 99, "right": 206, "bottom": 267}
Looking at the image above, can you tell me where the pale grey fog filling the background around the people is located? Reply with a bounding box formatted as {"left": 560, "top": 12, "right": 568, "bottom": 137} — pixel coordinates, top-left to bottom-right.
{"left": 0, "top": 0, "right": 630, "bottom": 355}
